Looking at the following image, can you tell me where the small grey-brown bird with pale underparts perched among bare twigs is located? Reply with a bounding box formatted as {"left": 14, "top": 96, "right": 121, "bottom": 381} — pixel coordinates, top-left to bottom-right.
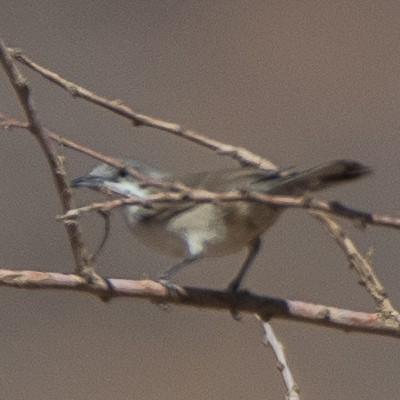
{"left": 71, "top": 159, "right": 371, "bottom": 292}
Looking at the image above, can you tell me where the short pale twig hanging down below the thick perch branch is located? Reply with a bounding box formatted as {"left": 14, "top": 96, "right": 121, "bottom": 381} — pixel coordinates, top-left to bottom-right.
{"left": 263, "top": 322, "right": 300, "bottom": 400}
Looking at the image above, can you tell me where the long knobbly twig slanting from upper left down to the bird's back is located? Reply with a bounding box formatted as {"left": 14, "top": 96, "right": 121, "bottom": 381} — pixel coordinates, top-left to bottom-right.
{"left": 9, "top": 48, "right": 276, "bottom": 169}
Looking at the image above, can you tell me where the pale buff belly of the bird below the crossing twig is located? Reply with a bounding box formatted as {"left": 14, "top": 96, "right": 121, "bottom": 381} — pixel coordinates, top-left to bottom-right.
{"left": 123, "top": 202, "right": 281, "bottom": 258}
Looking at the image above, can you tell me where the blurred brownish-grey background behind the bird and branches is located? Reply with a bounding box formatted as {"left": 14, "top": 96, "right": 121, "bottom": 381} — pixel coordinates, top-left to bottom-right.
{"left": 0, "top": 0, "right": 400, "bottom": 400}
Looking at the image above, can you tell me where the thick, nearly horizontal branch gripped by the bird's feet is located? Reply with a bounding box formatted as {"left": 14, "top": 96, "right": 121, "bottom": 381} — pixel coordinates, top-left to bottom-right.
{"left": 0, "top": 268, "right": 400, "bottom": 338}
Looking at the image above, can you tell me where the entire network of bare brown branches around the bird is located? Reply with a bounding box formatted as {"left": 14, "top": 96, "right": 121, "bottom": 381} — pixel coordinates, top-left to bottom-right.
{"left": 0, "top": 42, "right": 400, "bottom": 399}
